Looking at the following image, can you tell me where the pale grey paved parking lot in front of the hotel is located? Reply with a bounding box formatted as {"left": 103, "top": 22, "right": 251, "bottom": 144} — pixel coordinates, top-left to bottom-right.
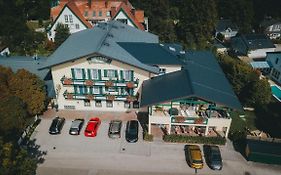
{"left": 32, "top": 110, "right": 281, "bottom": 175}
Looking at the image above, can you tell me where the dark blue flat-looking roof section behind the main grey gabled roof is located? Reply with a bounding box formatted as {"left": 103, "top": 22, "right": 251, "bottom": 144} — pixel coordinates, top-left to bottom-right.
{"left": 118, "top": 42, "right": 184, "bottom": 65}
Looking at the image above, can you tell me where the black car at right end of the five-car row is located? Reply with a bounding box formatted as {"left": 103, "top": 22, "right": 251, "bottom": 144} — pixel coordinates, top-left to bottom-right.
{"left": 126, "top": 120, "right": 139, "bottom": 143}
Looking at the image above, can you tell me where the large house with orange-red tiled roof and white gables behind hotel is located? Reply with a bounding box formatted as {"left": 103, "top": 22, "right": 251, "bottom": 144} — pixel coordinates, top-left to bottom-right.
{"left": 48, "top": 0, "right": 148, "bottom": 40}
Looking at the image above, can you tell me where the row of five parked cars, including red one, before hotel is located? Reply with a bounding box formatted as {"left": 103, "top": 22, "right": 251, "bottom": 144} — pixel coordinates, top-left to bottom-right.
{"left": 49, "top": 116, "right": 139, "bottom": 143}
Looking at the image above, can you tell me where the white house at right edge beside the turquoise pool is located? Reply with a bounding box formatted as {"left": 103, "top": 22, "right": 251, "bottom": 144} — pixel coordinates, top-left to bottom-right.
{"left": 266, "top": 52, "right": 281, "bottom": 83}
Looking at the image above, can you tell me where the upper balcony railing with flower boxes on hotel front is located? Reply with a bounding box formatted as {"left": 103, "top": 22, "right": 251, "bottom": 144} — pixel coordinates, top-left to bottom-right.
{"left": 61, "top": 76, "right": 139, "bottom": 88}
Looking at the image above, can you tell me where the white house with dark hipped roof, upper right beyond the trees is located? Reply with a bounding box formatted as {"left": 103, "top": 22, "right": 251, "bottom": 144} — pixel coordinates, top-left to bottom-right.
{"left": 230, "top": 34, "right": 275, "bottom": 58}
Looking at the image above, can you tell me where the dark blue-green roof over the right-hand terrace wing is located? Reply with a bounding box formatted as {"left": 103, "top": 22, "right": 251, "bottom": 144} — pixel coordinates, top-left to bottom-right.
{"left": 141, "top": 52, "right": 242, "bottom": 110}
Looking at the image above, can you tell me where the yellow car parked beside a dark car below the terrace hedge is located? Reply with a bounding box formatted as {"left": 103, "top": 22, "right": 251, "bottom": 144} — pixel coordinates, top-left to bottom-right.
{"left": 185, "top": 145, "right": 203, "bottom": 169}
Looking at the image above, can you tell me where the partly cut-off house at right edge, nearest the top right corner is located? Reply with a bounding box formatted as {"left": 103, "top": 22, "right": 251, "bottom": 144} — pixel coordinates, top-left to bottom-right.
{"left": 260, "top": 19, "right": 281, "bottom": 39}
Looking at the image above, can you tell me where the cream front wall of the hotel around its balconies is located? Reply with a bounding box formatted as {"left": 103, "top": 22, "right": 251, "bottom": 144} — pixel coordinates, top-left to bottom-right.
{"left": 51, "top": 55, "right": 151, "bottom": 111}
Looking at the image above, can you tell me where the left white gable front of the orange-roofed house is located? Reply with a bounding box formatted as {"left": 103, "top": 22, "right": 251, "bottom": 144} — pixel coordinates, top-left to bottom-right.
{"left": 47, "top": 6, "right": 87, "bottom": 41}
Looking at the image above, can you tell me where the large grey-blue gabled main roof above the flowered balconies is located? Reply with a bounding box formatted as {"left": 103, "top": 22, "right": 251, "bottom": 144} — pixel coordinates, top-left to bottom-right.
{"left": 41, "top": 21, "right": 159, "bottom": 73}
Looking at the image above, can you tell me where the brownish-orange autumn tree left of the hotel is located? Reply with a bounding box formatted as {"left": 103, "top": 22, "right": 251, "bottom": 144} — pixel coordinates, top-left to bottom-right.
{"left": 9, "top": 69, "right": 46, "bottom": 115}
